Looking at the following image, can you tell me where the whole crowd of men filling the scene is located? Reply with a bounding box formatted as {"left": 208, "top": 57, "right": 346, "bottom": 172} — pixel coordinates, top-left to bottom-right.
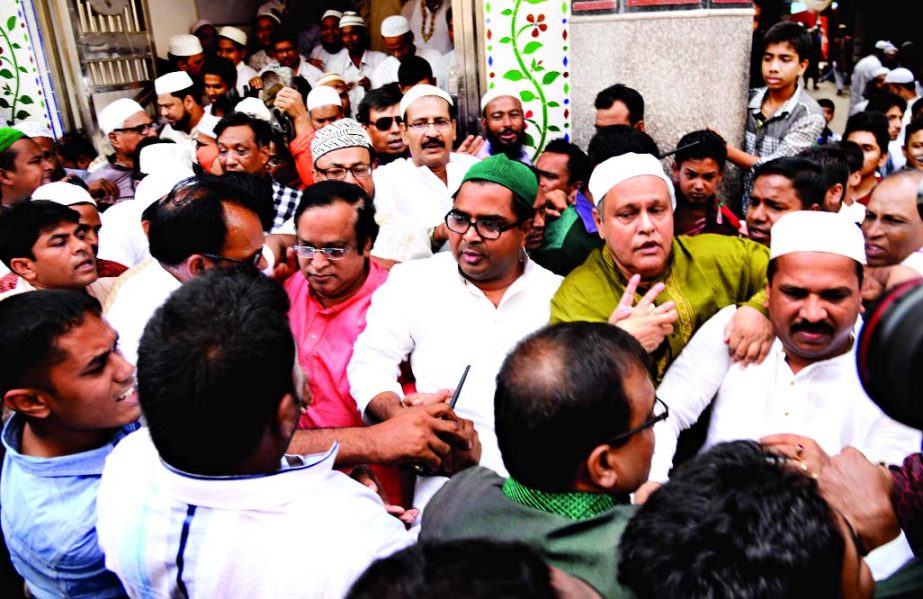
{"left": 0, "top": 0, "right": 923, "bottom": 598}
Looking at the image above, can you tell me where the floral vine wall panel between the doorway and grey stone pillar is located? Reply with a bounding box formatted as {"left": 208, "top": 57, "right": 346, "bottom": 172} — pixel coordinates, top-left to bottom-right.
{"left": 484, "top": 0, "right": 570, "bottom": 162}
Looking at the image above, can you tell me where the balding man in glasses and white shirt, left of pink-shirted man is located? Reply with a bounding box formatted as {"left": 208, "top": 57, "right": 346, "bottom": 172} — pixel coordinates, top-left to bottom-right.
{"left": 103, "top": 174, "right": 269, "bottom": 364}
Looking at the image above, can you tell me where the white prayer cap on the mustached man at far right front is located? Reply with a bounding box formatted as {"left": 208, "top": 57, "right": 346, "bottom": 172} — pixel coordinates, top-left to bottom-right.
{"left": 769, "top": 210, "right": 865, "bottom": 264}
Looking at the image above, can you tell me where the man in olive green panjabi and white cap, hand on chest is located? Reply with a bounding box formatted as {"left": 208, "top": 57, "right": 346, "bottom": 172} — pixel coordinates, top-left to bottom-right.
{"left": 551, "top": 153, "right": 772, "bottom": 383}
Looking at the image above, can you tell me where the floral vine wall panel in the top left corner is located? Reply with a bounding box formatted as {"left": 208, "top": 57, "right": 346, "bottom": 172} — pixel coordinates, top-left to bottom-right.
{"left": 0, "top": 0, "right": 61, "bottom": 135}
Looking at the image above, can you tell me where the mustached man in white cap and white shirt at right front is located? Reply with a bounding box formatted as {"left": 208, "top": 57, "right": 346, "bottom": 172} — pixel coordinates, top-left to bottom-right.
{"left": 636, "top": 210, "right": 921, "bottom": 578}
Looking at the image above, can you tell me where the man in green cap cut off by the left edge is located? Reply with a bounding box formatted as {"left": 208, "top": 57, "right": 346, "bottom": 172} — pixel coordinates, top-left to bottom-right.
{"left": 0, "top": 127, "right": 54, "bottom": 210}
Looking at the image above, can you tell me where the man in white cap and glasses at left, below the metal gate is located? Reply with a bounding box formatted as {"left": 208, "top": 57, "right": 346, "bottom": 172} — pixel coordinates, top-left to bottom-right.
{"left": 87, "top": 98, "right": 157, "bottom": 208}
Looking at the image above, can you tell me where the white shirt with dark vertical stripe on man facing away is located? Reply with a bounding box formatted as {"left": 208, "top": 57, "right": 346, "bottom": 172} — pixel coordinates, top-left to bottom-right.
{"left": 96, "top": 429, "right": 412, "bottom": 599}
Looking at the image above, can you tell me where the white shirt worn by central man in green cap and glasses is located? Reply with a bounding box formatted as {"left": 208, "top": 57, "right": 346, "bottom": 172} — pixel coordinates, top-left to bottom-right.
{"left": 347, "top": 252, "right": 562, "bottom": 507}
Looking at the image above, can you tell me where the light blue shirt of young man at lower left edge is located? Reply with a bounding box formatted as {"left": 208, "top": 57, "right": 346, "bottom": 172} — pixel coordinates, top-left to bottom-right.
{"left": 0, "top": 414, "right": 138, "bottom": 599}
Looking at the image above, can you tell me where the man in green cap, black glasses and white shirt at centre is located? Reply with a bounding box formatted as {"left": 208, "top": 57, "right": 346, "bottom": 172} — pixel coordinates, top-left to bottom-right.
{"left": 347, "top": 155, "right": 561, "bottom": 508}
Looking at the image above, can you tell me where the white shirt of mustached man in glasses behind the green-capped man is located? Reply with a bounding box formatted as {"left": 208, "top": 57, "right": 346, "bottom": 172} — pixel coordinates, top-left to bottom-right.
{"left": 372, "top": 153, "right": 479, "bottom": 262}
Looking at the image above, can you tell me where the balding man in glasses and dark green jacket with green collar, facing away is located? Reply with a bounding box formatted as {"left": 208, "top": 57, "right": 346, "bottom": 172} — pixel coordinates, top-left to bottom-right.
{"left": 420, "top": 322, "right": 652, "bottom": 597}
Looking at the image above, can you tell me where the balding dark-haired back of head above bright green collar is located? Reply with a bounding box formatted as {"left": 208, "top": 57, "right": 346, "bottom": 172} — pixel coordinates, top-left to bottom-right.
{"left": 494, "top": 322, "right": 647, "bottom": 492}
